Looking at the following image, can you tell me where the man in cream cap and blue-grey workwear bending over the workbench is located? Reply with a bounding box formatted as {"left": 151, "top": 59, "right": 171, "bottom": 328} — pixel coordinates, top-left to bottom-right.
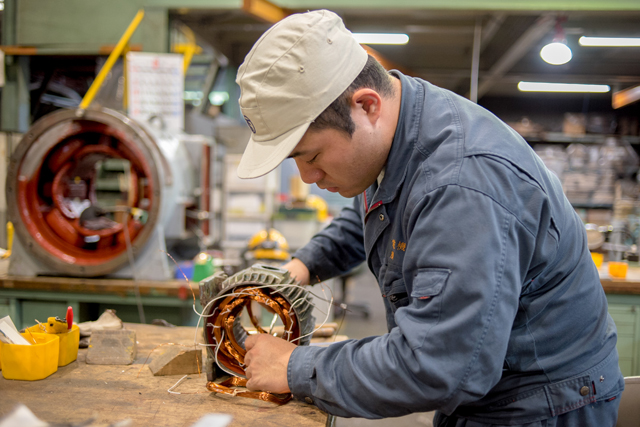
{"left": 232, "top": 11, "right": 624, "bottom": 427}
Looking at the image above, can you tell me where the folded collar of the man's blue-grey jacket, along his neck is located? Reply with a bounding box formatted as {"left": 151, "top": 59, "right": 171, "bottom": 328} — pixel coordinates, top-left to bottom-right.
{"left": 363, "top": 70, "right": 425, "bottom": 212}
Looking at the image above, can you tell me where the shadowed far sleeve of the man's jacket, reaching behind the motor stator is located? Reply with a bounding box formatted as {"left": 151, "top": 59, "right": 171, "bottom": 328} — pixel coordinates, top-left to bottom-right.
{"left": 293, "top": 197, "right": 365, "bottom": 283}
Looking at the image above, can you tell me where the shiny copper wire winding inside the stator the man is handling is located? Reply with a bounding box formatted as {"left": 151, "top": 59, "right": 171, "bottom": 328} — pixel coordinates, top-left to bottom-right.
{"left": 205, "top": 285, "right": 300, "bottom": 405}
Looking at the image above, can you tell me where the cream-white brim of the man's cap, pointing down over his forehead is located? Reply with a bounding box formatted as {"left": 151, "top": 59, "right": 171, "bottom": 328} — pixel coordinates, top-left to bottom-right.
{"left": 238, "top": 123, "right": 311, "bottom": 179}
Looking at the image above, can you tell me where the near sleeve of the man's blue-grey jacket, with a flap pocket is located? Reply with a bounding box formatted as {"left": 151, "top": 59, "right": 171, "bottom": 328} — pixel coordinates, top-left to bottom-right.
{"left": 288, "top": 185, "right": 535, "bottom": 418}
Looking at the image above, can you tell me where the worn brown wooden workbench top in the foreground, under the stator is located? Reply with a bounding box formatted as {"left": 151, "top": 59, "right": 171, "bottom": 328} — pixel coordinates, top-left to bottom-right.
{"left": 0, "top": 323, "right": 327, "bottom": 427}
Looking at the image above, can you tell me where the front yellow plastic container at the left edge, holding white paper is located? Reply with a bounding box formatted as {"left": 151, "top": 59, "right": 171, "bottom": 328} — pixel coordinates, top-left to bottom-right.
{"left": 0, "top": 332, "right": 60, "bottom": 381}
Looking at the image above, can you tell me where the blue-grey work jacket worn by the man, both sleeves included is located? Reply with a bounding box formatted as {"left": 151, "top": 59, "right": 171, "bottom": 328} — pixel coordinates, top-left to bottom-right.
{"left": 288, "top": 72, "right": 624, "bottom": 425}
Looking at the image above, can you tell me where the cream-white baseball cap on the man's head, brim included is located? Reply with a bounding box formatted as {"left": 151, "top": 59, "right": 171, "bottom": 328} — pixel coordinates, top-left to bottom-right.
{"left": 236, "top": 10, "right": 367, "bottom": 178}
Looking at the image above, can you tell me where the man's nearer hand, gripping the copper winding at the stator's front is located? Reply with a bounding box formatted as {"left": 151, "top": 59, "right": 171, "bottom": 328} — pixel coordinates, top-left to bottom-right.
{"left": 244, "top": 334, "right": 296, "bottom": 393}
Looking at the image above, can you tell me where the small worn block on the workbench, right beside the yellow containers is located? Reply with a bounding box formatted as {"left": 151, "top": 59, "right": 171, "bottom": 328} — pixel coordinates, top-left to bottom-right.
{"left": 87, "top": 329, "right": 138, "bottom": 365}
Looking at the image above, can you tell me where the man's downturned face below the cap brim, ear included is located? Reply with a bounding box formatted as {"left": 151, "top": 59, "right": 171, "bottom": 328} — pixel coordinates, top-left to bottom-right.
{"left": 291, "top": 122, "right": 389, "bottom": 197}
